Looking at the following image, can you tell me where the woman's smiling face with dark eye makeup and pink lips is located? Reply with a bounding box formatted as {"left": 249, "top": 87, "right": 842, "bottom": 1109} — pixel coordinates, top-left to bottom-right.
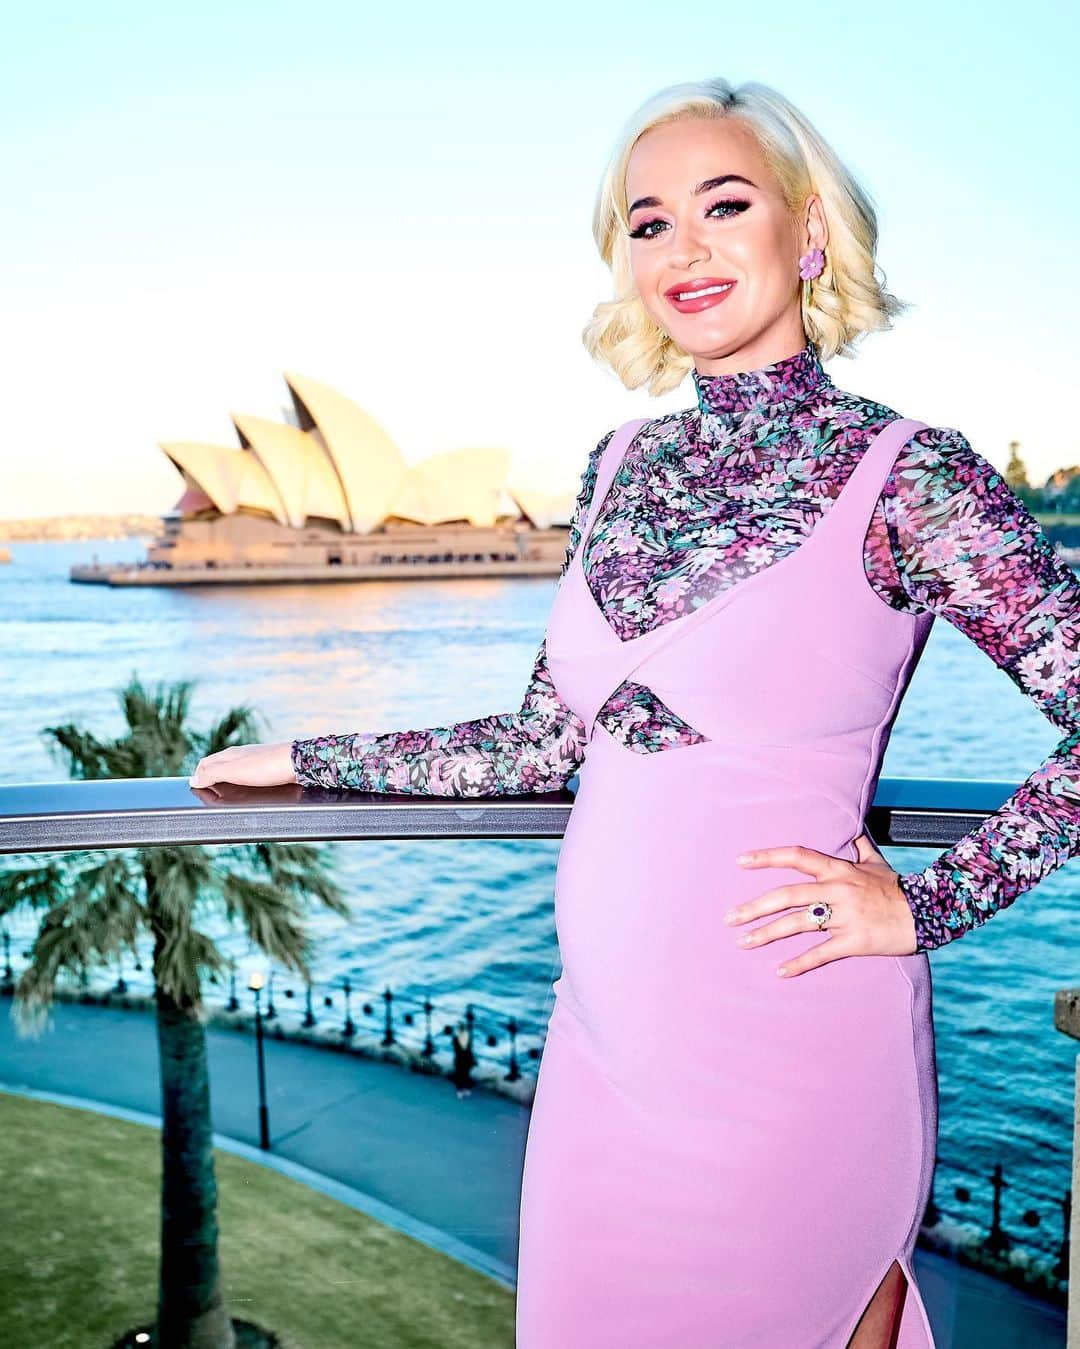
{"left": 626, "top": 117, "right": 827, "bottom": 375}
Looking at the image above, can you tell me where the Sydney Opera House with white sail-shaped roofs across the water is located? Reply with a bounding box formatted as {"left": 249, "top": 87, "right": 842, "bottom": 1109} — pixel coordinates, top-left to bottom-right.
{"left": 70, "top": 374, "right": 576, "bottom": 585}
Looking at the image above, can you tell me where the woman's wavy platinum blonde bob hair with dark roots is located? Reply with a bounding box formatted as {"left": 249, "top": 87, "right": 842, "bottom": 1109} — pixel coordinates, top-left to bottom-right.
{"left": 581, "top": 78, "right": 907, "bottom": 395}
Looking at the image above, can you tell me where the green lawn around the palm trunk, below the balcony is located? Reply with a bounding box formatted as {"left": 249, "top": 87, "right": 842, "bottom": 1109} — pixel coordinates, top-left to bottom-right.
{"left": 0, "top": 1094, "right": 514, "bottom": 1349}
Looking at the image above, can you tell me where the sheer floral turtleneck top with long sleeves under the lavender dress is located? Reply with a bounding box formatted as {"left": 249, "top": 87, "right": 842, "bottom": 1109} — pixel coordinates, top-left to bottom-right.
{"left": 291, "top": 344, "right": 1080, "bottom": 951}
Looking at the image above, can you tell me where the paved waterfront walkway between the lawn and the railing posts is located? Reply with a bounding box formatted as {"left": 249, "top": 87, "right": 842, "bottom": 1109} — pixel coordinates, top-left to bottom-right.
{"left": 0, "top": 1000, "right": 1065, "bottom": 1349}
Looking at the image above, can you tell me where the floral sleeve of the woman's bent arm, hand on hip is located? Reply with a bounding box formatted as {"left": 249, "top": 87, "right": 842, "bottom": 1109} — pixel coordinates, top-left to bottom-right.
{"left": 883, "top": 428, "right": 1080, "bottom": 951}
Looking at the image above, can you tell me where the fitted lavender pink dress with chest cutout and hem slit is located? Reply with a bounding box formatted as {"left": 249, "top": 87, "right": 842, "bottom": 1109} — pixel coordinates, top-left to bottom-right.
{"left": 506, "top": 421, "right": 937, "bottom": 1349}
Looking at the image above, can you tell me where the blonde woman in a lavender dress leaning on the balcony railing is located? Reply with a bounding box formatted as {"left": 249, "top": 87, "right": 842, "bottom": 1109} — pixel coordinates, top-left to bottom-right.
{"left": 193, "top": 80, "right": 1080, "bottom": 1349}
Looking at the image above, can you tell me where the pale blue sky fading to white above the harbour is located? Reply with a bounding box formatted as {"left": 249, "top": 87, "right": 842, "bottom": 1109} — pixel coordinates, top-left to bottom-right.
{"left": 0, "top": 0, "right": 1080, "bottom": 518}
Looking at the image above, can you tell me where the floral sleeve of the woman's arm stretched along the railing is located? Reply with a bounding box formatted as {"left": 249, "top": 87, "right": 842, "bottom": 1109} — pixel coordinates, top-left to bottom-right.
{"left": 290, "top": 430, "right": 613, "bottom": 796}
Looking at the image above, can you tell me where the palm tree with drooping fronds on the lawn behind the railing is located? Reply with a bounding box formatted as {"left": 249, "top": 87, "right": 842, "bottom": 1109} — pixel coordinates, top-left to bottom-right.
{"left": 0, "top": 676, "right": 349, "bottom": 1349}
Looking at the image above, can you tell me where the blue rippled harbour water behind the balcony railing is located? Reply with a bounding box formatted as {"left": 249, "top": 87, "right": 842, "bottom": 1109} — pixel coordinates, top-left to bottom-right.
{"left": 0, "top": 540, "right": 1080, "bottom": 1251}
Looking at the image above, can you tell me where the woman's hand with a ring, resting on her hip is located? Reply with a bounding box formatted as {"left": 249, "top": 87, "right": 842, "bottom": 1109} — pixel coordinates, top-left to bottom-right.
{"left": 724, "top": 834, "right": 918, "bottom": 974}
